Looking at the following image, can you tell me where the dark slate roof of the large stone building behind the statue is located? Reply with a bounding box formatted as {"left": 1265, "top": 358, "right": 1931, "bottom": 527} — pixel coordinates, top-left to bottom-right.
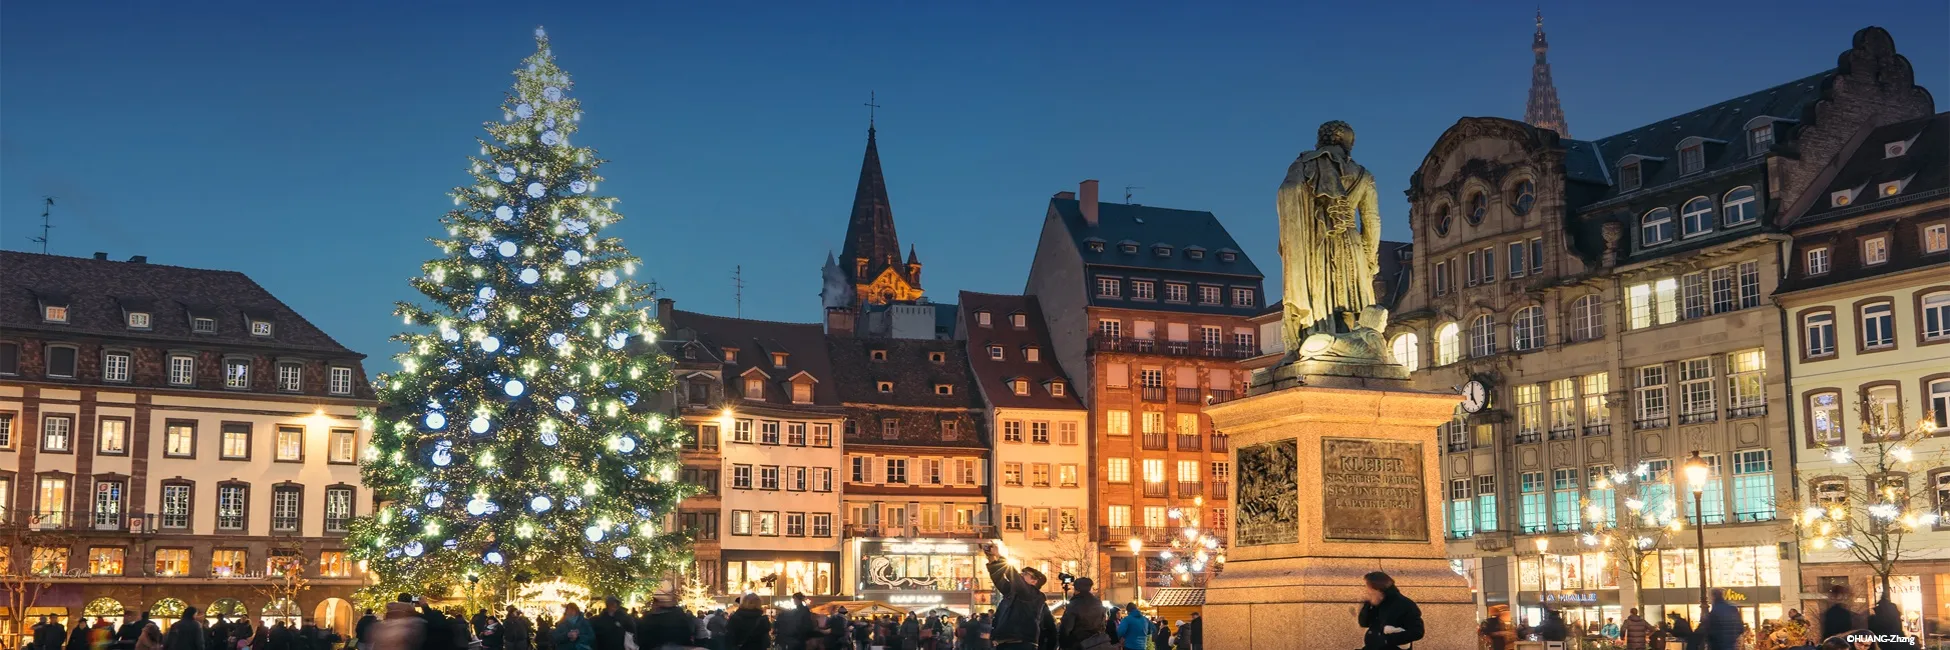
{"left": 1564, "top": 68, "right": 1835, "bottom": 201}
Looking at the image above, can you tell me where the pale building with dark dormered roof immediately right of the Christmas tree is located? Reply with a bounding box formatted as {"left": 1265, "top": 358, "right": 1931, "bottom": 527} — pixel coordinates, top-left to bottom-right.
{"left": 657, "top": 301, "right": 842, "bottom": 599}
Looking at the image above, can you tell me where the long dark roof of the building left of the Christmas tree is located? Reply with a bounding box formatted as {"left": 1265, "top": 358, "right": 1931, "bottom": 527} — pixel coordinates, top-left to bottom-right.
{"left": 0, "top": 250, "right": 365, "bottom": 359}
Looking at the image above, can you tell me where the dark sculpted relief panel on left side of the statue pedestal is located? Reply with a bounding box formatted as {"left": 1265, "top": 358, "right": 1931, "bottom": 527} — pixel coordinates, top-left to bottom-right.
{"left": 1232, "top": 437, "right": 1301, "bottom": 547}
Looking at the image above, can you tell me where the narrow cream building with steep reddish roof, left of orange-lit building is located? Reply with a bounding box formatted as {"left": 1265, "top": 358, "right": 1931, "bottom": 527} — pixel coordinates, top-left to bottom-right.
{"left": 957, "top": 291, "right": 1098, "bottom": 585}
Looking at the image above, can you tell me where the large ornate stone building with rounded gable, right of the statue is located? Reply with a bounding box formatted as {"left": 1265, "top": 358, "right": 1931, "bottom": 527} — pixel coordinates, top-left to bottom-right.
{"left": 1390, "top": 27, "right": 1932, "bottom": 621}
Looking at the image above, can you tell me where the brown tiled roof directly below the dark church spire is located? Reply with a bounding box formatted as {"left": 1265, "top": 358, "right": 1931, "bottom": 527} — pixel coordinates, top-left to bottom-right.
{"left": 827, "top": 336, "right": 981, "bottom": 408}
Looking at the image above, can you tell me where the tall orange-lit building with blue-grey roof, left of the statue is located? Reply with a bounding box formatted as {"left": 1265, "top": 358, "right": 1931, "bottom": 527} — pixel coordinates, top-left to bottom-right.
{"left": 1024, "top": 180, "right": 1264, "bottom": 599}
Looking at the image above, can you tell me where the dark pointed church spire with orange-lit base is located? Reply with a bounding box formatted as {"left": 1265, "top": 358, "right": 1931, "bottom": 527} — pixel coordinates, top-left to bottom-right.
{"left": 839, "top": 127, "right": 920, "bottom": 308}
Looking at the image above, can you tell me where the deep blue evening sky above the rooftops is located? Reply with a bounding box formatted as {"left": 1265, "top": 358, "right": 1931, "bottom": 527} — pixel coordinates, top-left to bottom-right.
{"left": 0, "top": 0, "right": 1950, "bottom": 371}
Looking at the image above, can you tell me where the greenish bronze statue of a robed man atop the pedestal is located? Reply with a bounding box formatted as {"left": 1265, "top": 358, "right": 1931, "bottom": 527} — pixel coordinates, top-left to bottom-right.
{"left": 1279, "top": 119, "right": 1381, "bottom": 363}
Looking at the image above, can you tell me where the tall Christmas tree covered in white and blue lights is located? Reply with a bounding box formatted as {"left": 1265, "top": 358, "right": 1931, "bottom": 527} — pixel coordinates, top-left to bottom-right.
{"left": 353, "top": 29, "right": 694, "bottom": 597}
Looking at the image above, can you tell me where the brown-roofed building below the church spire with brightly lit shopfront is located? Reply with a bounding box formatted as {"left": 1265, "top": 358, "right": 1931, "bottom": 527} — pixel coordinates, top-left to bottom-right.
{"left": 827, "top": 336, "right": 996, "bottom": 613}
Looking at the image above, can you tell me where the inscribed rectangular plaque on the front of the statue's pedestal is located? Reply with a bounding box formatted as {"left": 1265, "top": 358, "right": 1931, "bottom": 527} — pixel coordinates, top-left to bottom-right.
{"left": 1318, "top": 437, "right": 1429, "bottom": 543}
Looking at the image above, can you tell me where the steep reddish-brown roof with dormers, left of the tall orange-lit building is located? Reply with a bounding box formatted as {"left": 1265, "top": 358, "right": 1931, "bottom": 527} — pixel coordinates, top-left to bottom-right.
{"left": 961, "top": 291, "right": 1084, "bottom": 410}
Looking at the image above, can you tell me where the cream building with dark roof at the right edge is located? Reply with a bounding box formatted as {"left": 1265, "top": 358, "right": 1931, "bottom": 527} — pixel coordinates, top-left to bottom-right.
{"left": 1775, "top": 113, "right": 1950, "bottom": 632}
